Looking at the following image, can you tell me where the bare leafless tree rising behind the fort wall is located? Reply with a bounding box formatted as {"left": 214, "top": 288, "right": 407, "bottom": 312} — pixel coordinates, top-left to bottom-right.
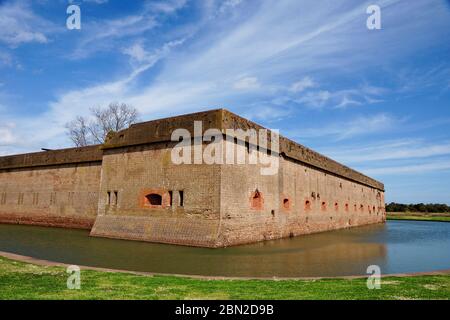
{"left": 66, "top": 103, "right": 139, "bottom": 147}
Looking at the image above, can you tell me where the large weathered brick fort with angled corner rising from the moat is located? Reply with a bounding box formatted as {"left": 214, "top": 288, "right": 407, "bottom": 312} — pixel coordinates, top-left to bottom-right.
{"left": 0, "top": 109, "right": 386, "bottom": 247}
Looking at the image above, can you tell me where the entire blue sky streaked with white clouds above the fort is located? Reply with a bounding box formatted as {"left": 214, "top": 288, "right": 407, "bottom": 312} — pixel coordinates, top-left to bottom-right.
{"left": 0, "top": 0, "right": 450, "bottom": 204}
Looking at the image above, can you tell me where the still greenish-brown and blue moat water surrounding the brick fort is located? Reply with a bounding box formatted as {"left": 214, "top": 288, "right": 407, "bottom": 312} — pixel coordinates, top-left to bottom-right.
{"left": 0, "top": 221, "right": 450, "bottom": 277}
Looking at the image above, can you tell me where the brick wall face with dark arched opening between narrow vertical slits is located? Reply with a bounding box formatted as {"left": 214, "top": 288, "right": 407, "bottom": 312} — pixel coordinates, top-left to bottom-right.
{"left": 91, "top": 142, "right": 220, "bottom": 247}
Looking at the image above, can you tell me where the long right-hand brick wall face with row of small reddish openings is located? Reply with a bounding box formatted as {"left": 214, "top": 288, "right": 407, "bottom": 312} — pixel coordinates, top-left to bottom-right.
{"left": 216, "top": 145, "right": 386, "bottom": 246}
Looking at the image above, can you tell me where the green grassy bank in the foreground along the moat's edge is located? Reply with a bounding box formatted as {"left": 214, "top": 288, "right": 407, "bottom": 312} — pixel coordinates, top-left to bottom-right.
{"left": 0, "top": 257, "right": 450, "bottom": 299}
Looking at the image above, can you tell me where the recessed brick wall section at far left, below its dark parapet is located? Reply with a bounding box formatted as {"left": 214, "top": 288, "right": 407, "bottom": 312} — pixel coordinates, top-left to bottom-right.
{"left": 0, "top": 162, "right": 101, "bottom": 229}
